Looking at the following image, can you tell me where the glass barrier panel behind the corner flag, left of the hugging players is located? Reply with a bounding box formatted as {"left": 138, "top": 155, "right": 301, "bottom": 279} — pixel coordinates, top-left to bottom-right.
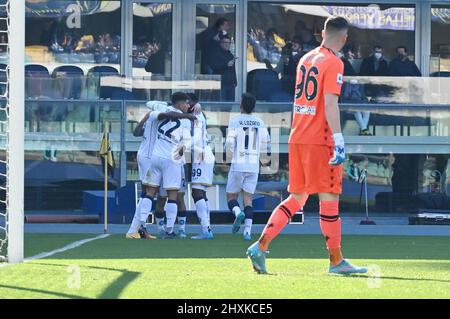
{"left": 25, "top": 100, "right": 121, "bottom": 213}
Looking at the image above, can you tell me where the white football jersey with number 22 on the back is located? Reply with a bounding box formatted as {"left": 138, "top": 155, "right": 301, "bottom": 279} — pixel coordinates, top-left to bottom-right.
{"left": 153, "top": 107, "right": 191, "bottom": 162}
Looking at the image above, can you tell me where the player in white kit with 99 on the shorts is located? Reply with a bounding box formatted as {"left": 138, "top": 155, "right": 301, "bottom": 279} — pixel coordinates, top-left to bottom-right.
{"left": 188, "top": 93, "right": 214, "bottom": 239}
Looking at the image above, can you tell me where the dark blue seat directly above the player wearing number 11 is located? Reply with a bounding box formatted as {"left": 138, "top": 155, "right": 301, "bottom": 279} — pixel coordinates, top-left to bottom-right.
{"left": 247, "top": 69, "right": 282, "bottom": 101}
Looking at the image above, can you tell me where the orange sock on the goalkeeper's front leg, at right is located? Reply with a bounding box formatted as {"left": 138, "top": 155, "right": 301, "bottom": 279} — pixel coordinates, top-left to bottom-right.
{"left": 320, "top": 201, "right": 343, "bottom": 266}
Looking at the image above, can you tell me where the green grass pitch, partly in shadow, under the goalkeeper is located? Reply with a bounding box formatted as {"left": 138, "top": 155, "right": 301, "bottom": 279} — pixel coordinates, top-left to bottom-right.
{"left": 0, "top": 234, "right": 450, "bottom": 299}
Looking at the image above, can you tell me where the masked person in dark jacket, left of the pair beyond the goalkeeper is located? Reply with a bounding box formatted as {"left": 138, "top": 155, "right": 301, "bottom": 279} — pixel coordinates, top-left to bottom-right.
{"left": 359, "top": 45, "right": 388, "bottom": 102}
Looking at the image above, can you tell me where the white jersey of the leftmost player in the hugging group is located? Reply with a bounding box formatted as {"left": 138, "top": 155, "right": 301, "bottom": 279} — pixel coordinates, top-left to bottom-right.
{"left": 138, "top": 101, "right": 169, "bottom": 158}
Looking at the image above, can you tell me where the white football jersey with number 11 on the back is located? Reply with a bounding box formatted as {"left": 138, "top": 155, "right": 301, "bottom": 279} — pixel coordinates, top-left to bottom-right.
{"left": 226, "top": 114, "right": 270, "bottom": 173}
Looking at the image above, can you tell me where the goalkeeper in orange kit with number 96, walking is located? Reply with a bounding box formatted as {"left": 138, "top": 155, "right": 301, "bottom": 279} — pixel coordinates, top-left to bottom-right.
{"left": 247, "top": 17, "right": 367, "bottom": 274}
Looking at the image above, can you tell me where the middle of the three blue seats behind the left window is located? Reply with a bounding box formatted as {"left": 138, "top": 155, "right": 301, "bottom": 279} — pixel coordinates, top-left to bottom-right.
{"left": 52, "top": 65, "right": 84, "bottom": 99}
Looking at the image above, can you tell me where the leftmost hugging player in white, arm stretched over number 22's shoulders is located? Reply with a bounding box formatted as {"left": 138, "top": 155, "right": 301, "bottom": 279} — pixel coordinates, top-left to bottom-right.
{"left": 126, "top": 94, "right": 196, "bottom": 239}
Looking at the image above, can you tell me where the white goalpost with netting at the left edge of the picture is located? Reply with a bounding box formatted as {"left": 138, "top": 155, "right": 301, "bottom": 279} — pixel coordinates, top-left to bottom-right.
{"left": 0, "top": 0, "right": 25, "bottom": 264}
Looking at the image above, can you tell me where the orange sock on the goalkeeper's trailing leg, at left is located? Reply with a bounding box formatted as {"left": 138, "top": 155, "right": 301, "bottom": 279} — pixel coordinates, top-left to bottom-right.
{"left": 258, "top": 195, "right": 306, "bottom": 251}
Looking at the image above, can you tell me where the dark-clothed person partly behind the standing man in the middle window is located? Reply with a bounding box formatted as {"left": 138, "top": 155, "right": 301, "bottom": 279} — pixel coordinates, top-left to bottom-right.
{"left": 198, "top": 17, "right": 231, "bottom": 74}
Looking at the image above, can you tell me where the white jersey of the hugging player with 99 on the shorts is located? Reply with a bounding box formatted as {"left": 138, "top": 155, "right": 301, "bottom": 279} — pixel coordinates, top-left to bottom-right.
{"left": 192, "top": 113, "right": 214, "bottom": 164}
